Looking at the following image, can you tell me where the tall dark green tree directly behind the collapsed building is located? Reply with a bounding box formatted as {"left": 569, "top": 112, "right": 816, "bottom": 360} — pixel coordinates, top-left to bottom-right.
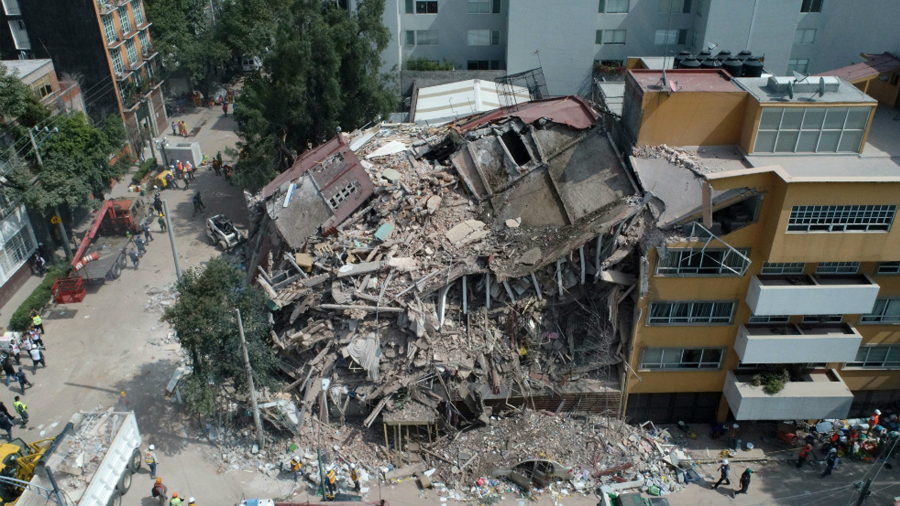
{"left": 235, "top": 0, "right": 396, "bottom": 189}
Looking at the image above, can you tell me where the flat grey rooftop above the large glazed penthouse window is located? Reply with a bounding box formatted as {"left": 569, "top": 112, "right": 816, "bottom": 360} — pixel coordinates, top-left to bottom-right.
{"left": 735, "top": 76, "right": 875, "bottom": 104}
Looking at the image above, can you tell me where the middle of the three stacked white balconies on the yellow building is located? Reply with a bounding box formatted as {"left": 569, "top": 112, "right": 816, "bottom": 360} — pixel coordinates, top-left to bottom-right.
{"left": 734, "top": 323, "right": 862, "bottom": 364}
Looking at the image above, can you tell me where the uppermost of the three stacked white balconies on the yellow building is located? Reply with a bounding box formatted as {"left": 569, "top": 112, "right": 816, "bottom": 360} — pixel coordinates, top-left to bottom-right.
{"left": 747, "top": 274, "right": 879, "bottom": 316}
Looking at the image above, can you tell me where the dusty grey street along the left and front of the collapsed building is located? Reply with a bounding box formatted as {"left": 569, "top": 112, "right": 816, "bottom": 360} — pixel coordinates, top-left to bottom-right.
{"left": 0, "top": 109, "right": 900, "bottom": 506}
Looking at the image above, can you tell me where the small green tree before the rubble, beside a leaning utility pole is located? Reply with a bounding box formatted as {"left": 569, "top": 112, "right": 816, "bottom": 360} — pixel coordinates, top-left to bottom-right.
{"left": 163, "top": 258, "right": 276, "bottom": 415}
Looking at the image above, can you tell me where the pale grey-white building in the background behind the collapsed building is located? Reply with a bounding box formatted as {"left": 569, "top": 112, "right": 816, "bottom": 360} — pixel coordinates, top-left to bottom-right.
{"left": 351, "top": 0, "right": 900, "bottom": 95}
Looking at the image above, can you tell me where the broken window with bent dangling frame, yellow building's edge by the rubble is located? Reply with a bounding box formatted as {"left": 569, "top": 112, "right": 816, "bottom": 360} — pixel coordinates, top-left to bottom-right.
{"left": 656, "top": 248, "right": 750, "bottom": 276}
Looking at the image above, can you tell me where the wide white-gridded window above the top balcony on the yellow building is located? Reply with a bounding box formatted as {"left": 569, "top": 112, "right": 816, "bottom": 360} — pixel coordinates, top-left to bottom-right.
{"left": 787, "top": 205, "right": 897, "bottom": 233}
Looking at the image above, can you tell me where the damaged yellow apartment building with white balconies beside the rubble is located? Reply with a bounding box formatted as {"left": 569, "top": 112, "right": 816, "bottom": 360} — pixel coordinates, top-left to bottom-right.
{"left": 617, "top": 66, "right": 900, "bottom": 422}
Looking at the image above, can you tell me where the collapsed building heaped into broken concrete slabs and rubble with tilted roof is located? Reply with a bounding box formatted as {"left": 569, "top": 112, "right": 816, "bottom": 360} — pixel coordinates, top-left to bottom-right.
{"left": 248, "top": 97, "right": 653, "bottom": 438}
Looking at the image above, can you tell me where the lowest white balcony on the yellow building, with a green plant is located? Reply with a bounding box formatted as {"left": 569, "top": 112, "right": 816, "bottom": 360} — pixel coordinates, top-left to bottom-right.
{"left": 724, "top": 369, "right": 853, "bottom": 420}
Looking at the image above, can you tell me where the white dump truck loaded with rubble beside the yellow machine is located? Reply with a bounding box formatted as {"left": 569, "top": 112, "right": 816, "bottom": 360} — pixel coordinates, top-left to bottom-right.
{"left": 16, "top": 408, "right": 142, "bottom": 506}
